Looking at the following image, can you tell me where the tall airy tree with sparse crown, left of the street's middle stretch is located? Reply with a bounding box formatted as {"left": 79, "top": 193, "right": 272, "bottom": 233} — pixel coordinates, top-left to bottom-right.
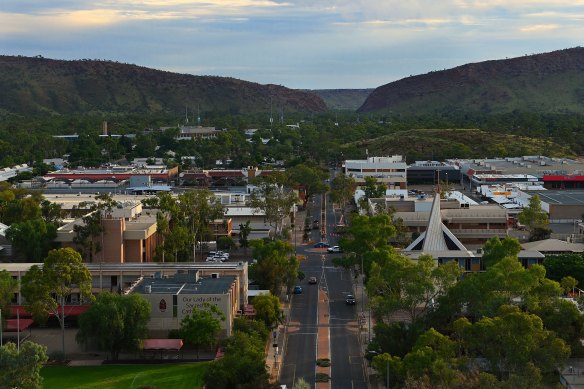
{"left": 249, "top": 180, "right": 298, "bottom": 236}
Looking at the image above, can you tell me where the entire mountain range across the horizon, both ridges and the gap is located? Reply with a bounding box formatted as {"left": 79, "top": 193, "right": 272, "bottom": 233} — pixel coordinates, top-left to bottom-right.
{"left": 0, "top": 47, "right": 584, "bottom": 116}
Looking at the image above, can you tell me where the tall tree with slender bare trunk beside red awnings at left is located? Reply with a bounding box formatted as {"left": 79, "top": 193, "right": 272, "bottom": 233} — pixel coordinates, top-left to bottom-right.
{"left": 21, "top": 248, "right": 93, "bottom": 354}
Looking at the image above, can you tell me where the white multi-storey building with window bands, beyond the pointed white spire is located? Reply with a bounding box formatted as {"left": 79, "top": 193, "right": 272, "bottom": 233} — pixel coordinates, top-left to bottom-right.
{"left": 343, "top": 155, "right": 407, "bottom": 189}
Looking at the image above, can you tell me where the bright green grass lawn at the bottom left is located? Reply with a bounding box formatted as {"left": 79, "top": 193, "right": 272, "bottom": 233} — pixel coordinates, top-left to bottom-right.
{"left": 41, "top": 362, "right": 208, "bottom": 389}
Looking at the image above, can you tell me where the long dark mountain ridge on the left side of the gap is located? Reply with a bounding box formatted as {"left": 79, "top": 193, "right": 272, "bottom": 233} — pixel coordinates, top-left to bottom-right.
{"left": 0, "top": 56, "right": 327, "bottom": 115}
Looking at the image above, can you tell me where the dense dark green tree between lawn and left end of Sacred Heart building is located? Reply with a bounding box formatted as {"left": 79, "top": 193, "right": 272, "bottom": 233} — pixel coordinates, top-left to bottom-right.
{"left": 76, "top": 292, "right": 150, "bottom": 361}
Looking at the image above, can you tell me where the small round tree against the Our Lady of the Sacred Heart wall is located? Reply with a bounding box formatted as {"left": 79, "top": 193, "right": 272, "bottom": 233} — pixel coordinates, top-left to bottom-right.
{"left": 180, "top": 303, "right": 225, "bottom": 359}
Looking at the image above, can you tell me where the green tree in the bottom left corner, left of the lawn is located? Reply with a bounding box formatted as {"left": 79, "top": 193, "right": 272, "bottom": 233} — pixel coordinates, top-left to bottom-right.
{"left": 0, "top": 341, "right": 48, "bottom": 389}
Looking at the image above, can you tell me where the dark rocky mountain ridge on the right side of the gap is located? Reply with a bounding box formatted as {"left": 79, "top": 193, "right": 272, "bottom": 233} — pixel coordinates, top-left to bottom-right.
{"left": 358, "top": 47, "right": 584, "bottom": 116}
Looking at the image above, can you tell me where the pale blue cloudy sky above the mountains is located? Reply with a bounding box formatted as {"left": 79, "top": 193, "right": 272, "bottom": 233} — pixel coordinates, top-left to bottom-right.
{"left": 0, "top": 0, "right": 584, "bottom": 89}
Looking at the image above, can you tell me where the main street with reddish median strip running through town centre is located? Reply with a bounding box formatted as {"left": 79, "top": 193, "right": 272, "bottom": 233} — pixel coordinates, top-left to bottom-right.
{"left": 280, "top": 187, "right": 367, "bottom": 389}
